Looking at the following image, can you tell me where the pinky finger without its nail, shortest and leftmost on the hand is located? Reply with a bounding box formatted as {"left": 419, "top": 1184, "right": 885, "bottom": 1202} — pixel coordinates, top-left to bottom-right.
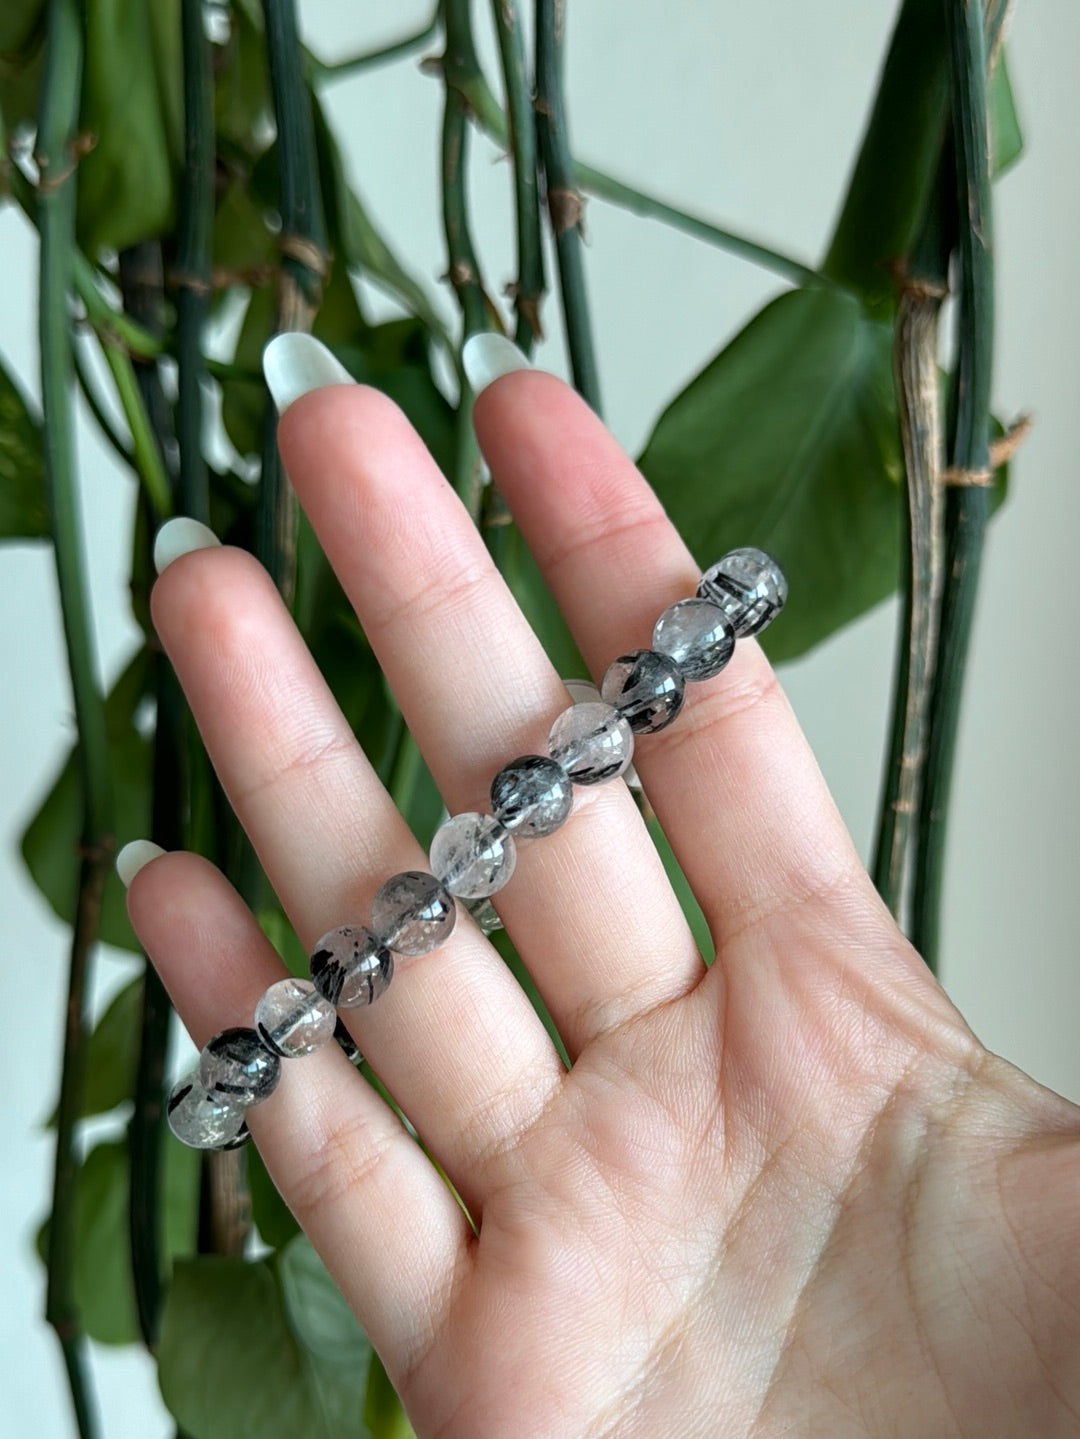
{"left": 128, "top": 853, "right": 469, "bottom": 1376}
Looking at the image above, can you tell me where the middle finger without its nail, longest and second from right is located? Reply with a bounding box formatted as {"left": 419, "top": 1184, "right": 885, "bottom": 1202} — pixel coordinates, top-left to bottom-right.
{"left": 279, "top": 386, "right": 702, "bottom": 1055}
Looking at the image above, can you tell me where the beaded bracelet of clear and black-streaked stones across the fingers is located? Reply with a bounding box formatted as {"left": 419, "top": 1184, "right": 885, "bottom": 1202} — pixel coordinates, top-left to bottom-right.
{"left": 167, "top": 548, "right": 788, "bottom": 1150}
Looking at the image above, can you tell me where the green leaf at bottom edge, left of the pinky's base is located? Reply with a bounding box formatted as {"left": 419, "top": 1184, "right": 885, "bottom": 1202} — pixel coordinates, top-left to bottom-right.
{"left": 158, "top": 1235, "right": 371, "bottom": 1439}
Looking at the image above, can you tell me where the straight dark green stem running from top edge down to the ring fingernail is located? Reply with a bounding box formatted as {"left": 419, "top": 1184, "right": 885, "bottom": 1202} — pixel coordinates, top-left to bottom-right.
{"left": 173, "top": 0, "right": 214, "bottom": 524}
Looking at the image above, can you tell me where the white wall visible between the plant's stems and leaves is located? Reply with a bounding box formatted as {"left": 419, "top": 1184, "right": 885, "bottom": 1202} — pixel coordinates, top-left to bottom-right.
{"left": 0, "top": 0, "right": 1080, "bottom": 1439}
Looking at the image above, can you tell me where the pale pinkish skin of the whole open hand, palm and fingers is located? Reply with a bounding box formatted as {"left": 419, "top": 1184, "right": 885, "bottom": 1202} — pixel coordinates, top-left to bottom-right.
{"left": 129, "top": 373, "right": 1080, "bottom": 1439}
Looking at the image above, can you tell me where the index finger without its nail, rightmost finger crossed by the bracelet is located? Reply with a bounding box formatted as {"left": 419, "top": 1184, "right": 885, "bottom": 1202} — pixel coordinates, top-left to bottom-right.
{"left": 475, "top": 371, "right": 897, "bottom": 948}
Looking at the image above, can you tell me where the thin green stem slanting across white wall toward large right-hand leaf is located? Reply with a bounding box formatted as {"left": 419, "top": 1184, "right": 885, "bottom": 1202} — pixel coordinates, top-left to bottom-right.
{"left": 465, "top": 71, "right": 834, "bottom": 285}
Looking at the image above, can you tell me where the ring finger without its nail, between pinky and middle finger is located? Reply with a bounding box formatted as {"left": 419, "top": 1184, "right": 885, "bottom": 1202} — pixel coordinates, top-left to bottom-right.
{"left": 152, "top": 548, "right": 562, "bottom": 1212}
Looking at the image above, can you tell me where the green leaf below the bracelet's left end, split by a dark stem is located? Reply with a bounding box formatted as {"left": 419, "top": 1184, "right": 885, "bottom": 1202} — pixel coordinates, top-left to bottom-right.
{"left": 37, "top": 1140, "right": 198, "bottom": 1344}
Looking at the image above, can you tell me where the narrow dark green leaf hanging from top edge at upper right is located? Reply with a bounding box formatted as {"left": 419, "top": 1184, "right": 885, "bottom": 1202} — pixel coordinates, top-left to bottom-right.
{"left": 823, "top": 0, "right": 949, "bottom": 309}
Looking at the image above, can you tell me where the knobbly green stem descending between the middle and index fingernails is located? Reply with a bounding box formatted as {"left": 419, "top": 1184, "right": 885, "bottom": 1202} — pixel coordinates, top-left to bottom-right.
{"left": 441, "top": 0, "right": 489, "bottom": 521}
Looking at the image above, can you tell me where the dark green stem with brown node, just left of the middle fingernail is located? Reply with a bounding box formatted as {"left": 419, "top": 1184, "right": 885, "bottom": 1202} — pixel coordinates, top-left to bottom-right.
{"left": 256, "top": 0, "right": 326, "bottom": 603}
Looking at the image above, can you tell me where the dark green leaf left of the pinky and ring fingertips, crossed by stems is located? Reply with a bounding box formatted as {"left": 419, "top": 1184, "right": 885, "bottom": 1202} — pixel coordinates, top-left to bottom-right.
{"left": 22, "top": 650, "right": 151, "bottom": 951}
